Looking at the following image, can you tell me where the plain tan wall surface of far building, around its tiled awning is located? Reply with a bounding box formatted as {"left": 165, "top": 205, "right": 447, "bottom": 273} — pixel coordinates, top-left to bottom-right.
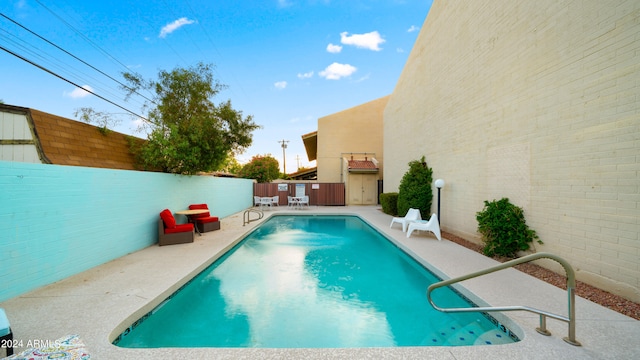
{"left": 316, "top": 96, "right": 389, "bottom": 182}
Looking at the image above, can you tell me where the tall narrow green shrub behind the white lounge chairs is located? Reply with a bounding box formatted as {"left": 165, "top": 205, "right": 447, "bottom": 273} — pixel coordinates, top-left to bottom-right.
{"left": 398, "top": 156, "right": 433, "bottom": 219}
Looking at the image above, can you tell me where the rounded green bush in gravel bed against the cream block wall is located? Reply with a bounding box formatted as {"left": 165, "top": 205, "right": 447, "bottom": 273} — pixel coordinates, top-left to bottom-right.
{"left": 476, "top": 198, "right": 542, "bottom": 258}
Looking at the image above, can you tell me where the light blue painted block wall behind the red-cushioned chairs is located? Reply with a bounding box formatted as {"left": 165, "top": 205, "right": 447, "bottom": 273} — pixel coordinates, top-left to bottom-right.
{"left": 0, "top": 161, "right": 253, "bottom": 302}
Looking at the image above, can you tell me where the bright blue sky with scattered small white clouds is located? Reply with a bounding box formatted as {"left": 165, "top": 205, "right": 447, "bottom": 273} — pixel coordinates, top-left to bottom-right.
{"left": 0, "top": 0, "right": 431, "bottom": 173}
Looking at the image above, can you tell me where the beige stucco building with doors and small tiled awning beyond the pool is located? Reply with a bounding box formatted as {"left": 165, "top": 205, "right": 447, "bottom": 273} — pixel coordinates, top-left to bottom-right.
{"left": 302, "top": 96, "right": 389, "bottom": 205}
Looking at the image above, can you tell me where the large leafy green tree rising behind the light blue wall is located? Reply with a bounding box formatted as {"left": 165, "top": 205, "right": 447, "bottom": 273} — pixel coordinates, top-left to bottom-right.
{"left": 123, "top": 63, "right": 260, "bottom": 175}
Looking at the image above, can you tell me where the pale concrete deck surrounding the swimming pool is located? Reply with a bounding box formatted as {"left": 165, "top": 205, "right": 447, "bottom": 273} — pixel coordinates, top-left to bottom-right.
{"left": 0, "top": 206, "right": 640, "bottom": 360}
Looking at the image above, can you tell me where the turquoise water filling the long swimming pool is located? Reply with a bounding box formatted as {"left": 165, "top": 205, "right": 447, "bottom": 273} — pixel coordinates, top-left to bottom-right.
{"left": 114, "top": 216, "right": 517, "bottom": 348}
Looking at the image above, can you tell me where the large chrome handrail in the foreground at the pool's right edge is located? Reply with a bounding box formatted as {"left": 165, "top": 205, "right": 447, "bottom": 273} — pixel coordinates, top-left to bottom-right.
{"left": 427, "top": 253, "right": 582, "bottom": 346}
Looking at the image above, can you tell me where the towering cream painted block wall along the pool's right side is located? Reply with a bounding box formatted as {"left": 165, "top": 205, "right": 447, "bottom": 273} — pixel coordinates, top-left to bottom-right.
{"left": 384, "top": 0, "right": 640, "bottom": 301}
